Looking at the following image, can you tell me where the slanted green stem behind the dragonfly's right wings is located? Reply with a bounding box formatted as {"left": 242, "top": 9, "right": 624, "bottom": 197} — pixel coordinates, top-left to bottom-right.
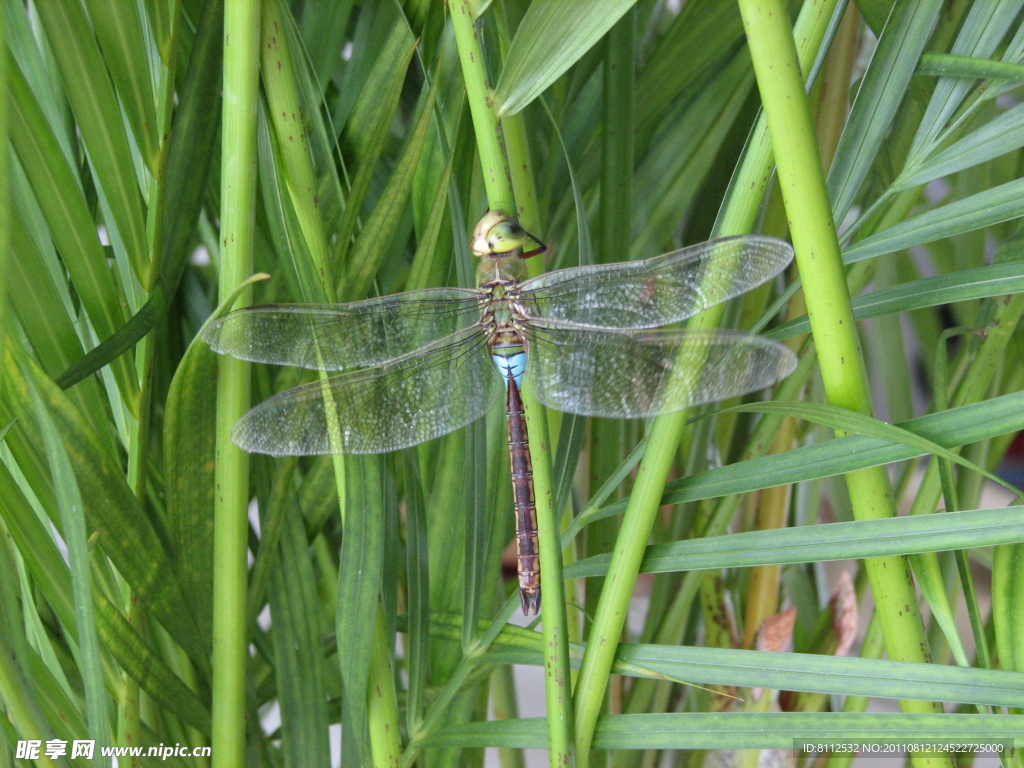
{"left": 573, "top": 0, "right": 836, "bottom": 765}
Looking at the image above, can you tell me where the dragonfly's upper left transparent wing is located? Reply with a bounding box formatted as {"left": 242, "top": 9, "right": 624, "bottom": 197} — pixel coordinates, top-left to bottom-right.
{"left": 203, "top": 288, "right": 481, "bottom": 371}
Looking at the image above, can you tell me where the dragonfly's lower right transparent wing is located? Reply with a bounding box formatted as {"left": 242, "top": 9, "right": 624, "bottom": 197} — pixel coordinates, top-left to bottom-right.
{"left": 526, "top": 323, "right": 797, "bottom": 419}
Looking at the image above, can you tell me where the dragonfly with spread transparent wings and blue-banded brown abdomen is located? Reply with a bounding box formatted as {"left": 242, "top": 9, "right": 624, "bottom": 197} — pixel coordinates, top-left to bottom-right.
{"left": 203, "top": 211, "right": 796, "bottom": 615}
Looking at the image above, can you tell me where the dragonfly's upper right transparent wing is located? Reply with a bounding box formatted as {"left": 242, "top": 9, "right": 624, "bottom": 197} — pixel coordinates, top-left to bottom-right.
{"left": 520, "top": 234, "right": 793, "bottom": 328}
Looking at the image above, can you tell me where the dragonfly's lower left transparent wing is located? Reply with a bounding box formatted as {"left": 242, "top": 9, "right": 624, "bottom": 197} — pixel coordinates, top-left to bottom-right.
{"left": 231, "top": 329, "right": 502, "bottom": 456}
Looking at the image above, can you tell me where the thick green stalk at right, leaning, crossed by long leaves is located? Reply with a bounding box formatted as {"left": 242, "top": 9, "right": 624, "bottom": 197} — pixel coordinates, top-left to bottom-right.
{"left": 739, "top": 0, "right": 941, "bottom": 757}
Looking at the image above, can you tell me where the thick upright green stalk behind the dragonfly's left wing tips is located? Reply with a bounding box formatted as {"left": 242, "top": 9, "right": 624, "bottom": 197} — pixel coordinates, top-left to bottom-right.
{"left": 211, "top": 0, "right": 260, "bottom": 768}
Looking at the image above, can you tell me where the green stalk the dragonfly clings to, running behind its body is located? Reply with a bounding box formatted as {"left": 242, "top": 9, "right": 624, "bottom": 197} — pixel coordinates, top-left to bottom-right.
{"left": 450, "top": 0, "right": 574, "bottom": 768}
